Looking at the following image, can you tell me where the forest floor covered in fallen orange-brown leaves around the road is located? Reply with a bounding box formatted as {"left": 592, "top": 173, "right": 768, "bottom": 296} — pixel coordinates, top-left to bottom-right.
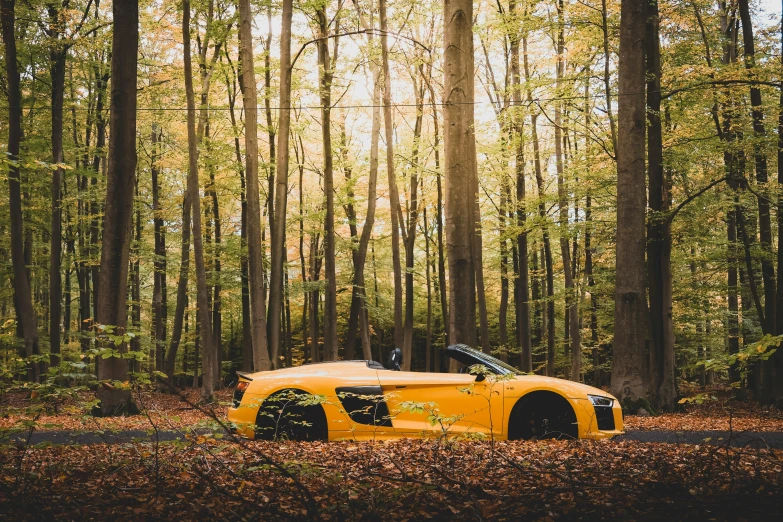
{"left": 0, "top": 389, "right": 783, "bottom": 521}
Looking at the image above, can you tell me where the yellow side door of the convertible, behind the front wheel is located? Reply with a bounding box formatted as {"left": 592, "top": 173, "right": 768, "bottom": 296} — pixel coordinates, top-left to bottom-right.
{"left": 378, "top": 370, "right": 504, "bottom": 436}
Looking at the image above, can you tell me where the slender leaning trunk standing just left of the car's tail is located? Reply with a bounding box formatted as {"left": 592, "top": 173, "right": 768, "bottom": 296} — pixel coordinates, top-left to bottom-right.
{"left": 182, "top": 0, "right": 217, "bottom": 402}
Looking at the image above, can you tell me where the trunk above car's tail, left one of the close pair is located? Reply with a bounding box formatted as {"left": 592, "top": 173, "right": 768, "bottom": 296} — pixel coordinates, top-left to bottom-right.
{"left": 239, "top": 0, "right": 270, "bottom": 371}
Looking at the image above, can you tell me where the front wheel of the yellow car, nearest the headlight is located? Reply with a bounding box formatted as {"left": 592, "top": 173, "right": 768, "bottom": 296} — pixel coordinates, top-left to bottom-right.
{"left": 508, "top": 391, "right": 579, "bottom": 440}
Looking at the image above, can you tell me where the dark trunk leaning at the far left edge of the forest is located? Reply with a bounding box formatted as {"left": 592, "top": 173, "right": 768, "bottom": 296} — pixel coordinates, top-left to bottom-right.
{"left": 0, "top": 0, "right": 40, "bottom": 382}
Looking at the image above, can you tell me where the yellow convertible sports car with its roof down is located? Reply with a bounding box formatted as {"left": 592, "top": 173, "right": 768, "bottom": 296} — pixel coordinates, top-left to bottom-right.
{"left": 228, "top": 345, "right": 623, "bottom": 440}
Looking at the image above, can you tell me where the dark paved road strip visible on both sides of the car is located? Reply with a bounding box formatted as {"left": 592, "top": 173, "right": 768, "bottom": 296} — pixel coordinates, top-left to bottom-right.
{"left": 0, "top": 430, "right": 783, "bottom": 449}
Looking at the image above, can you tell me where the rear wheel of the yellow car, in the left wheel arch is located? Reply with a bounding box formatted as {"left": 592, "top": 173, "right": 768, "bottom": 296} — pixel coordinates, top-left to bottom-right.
{"left": 255, "top": 389, "right": 329, "bottom": 441}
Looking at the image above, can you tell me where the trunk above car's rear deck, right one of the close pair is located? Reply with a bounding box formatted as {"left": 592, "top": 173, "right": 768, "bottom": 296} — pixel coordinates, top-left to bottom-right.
{"left": 266, "top": 0, "right": 292, "bottom": 365}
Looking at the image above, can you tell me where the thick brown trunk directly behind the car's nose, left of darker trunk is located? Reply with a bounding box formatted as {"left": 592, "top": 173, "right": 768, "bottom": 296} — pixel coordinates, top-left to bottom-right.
{"left": 611, "top": 0, "right": 648, "bottom": 405}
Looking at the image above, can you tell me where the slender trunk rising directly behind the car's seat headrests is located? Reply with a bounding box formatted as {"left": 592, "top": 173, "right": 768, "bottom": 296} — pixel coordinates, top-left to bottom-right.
{"left": 378, "top": 0, "right": 405, "bottom": 350}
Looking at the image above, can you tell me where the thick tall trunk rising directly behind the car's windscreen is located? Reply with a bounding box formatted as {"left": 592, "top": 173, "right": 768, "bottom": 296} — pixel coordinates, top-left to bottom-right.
{"left": 443, "top": 0, "right": 476, "bottom": 360}
